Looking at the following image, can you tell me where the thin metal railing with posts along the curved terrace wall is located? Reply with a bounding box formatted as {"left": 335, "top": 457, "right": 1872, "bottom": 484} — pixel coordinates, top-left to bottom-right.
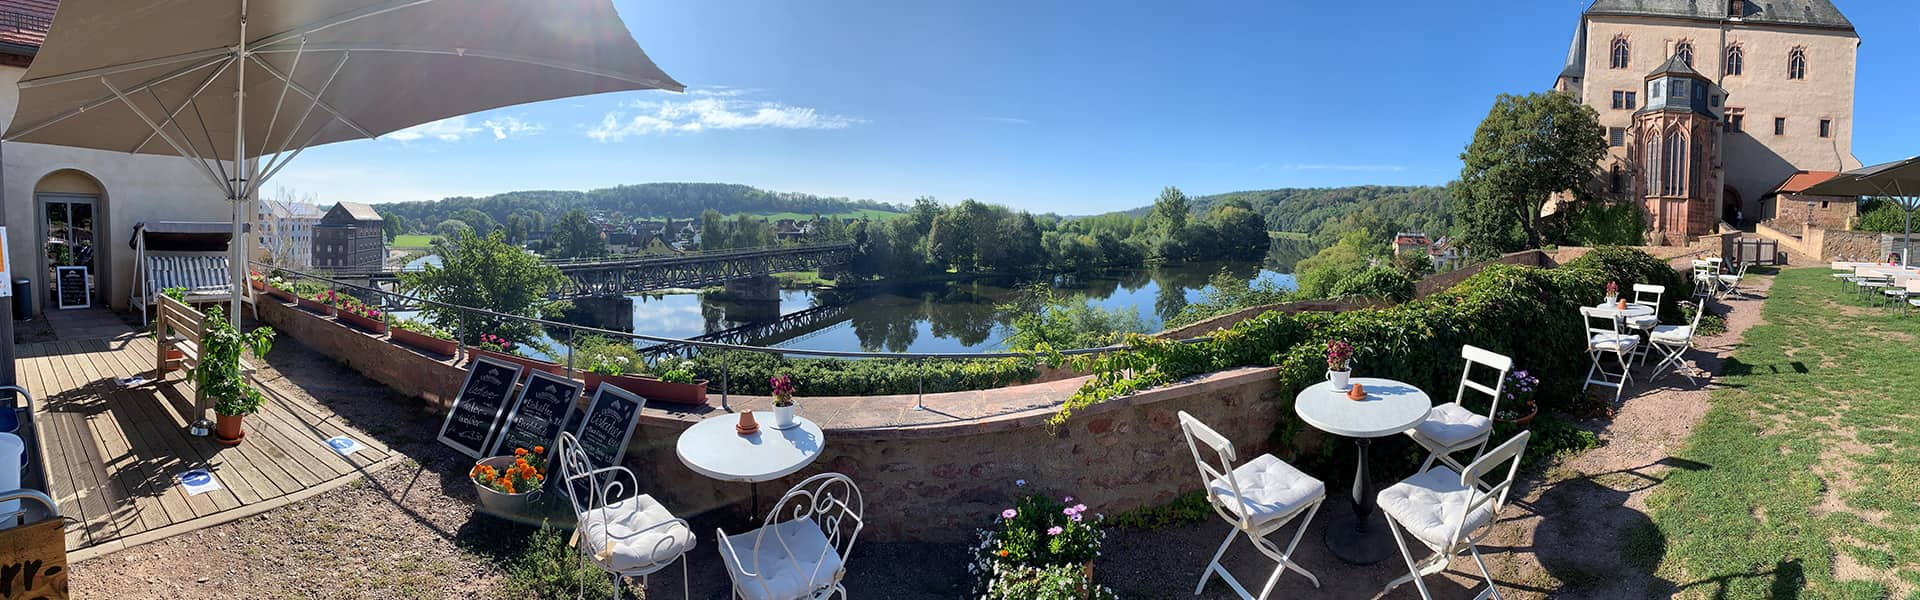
{"left": 253, "top": 262, "right": 1204, "bottom": 412}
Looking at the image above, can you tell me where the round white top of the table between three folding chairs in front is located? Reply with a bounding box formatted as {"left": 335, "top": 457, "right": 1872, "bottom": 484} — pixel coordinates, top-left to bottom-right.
{"left": 1294, "top": 377, "right": 1434, "bottom": 438}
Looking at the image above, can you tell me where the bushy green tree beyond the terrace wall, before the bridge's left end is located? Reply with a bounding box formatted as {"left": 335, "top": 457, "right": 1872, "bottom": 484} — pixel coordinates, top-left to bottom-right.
{"left": 399, "top": 223, "right": 566, "bottom": 344}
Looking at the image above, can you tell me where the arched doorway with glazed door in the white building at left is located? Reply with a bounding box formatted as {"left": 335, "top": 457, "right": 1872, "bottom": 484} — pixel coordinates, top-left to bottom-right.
{"left": 33, "top": 169, "right": 109, "bottom": 310}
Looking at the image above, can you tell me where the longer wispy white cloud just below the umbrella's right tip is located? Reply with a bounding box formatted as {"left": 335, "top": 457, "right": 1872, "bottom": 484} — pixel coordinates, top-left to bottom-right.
{"left": 588, "top": 88, "right": 864, "bottom": 142}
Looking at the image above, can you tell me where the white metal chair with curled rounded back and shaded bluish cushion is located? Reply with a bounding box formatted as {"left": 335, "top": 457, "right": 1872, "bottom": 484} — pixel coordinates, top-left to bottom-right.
{"left": 718, "top": 473, "right": 866, "bottom": 600}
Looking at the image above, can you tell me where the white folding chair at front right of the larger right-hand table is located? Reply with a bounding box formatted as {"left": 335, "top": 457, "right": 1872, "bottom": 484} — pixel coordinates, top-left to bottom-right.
{"left": 1379, "top": 431, "right": 1532, "bottom": 600}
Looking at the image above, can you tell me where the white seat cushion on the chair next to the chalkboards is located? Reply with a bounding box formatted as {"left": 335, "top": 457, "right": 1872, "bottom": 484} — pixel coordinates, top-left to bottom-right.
{"left": 580, "top": 494, "right": 693, "bottom": 571}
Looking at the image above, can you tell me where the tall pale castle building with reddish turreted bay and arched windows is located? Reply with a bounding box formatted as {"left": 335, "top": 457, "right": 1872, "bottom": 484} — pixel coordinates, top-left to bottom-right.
{"left": 1553, "top": 0, "right": 1860, "bottom": 244}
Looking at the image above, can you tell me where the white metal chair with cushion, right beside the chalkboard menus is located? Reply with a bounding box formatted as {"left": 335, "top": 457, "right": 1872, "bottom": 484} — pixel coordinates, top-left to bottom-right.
{"left": 553, "top": 433, "right": 693, "bottom": 598}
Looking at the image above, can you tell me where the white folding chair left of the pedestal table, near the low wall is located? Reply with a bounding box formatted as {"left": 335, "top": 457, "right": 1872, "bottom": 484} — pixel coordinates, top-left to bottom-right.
{"left": 1179, "top": 410, "right": 1327, "bottom": 600}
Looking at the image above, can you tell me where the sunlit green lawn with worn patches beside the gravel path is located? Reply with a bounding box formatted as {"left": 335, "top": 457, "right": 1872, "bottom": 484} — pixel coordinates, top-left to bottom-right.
{"left": 1640, "top": 269, "right": 1920, "bottom": 598}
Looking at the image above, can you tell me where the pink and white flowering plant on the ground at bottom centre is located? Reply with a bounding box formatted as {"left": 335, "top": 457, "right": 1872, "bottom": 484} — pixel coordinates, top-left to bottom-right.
{"left": 968, "top": 481, "right": 1116, "bottom": 600}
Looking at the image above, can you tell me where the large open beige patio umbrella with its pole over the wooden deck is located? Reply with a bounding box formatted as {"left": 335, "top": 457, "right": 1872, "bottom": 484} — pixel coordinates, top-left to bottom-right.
{"left": 6, "top": 0, "right": 684, "bottom": 328}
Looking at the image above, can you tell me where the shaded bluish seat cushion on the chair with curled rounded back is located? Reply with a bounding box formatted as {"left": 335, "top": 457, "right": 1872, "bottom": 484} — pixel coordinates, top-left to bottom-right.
{"left": 720, "top": 517, "right": 845, "bottom": 600}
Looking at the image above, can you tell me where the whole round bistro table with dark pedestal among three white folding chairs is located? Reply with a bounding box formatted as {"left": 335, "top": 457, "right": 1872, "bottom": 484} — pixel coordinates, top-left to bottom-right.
{"left": 1294, "top": 377, "right": 1434, "bottom": 565}
